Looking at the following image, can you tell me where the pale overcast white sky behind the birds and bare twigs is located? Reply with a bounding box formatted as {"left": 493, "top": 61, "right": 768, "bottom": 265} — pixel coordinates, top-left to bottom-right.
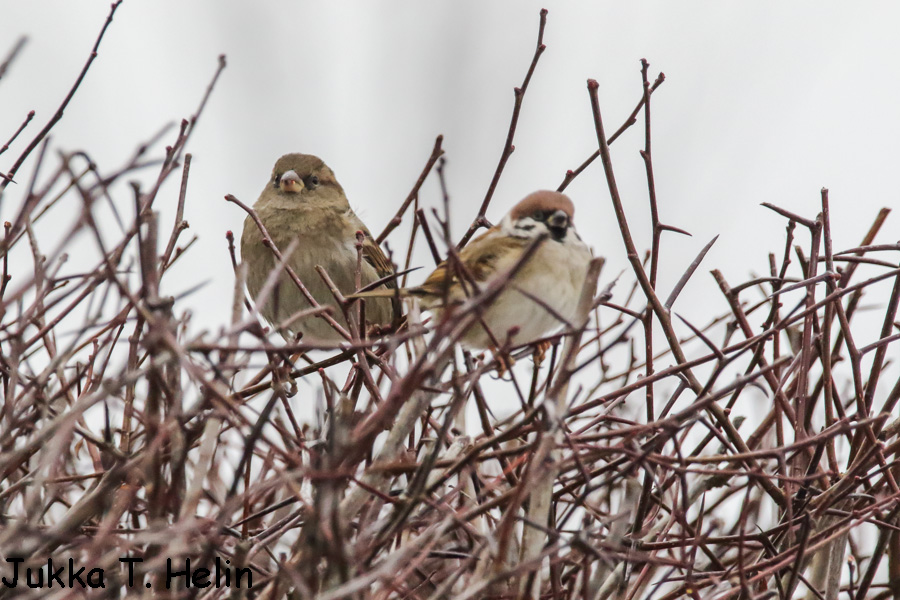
{"left": 0, "top": 0, "right": 900, "bottom": 342}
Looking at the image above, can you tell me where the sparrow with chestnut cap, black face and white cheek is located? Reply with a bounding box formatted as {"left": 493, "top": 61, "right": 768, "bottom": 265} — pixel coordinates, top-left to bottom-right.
{"left": 352, "top": 191, "right": 591, "bottom": 349}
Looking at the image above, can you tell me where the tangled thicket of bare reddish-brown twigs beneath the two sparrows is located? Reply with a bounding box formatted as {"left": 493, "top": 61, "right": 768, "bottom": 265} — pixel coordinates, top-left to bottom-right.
{"left": 0, "top": 4, "right": 900, "bottom": 600}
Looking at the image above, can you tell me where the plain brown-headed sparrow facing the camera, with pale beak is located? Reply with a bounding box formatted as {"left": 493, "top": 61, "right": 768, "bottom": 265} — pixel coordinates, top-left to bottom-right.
{"left": 241, "top": 154, "right": 396, "bottom": 341}
